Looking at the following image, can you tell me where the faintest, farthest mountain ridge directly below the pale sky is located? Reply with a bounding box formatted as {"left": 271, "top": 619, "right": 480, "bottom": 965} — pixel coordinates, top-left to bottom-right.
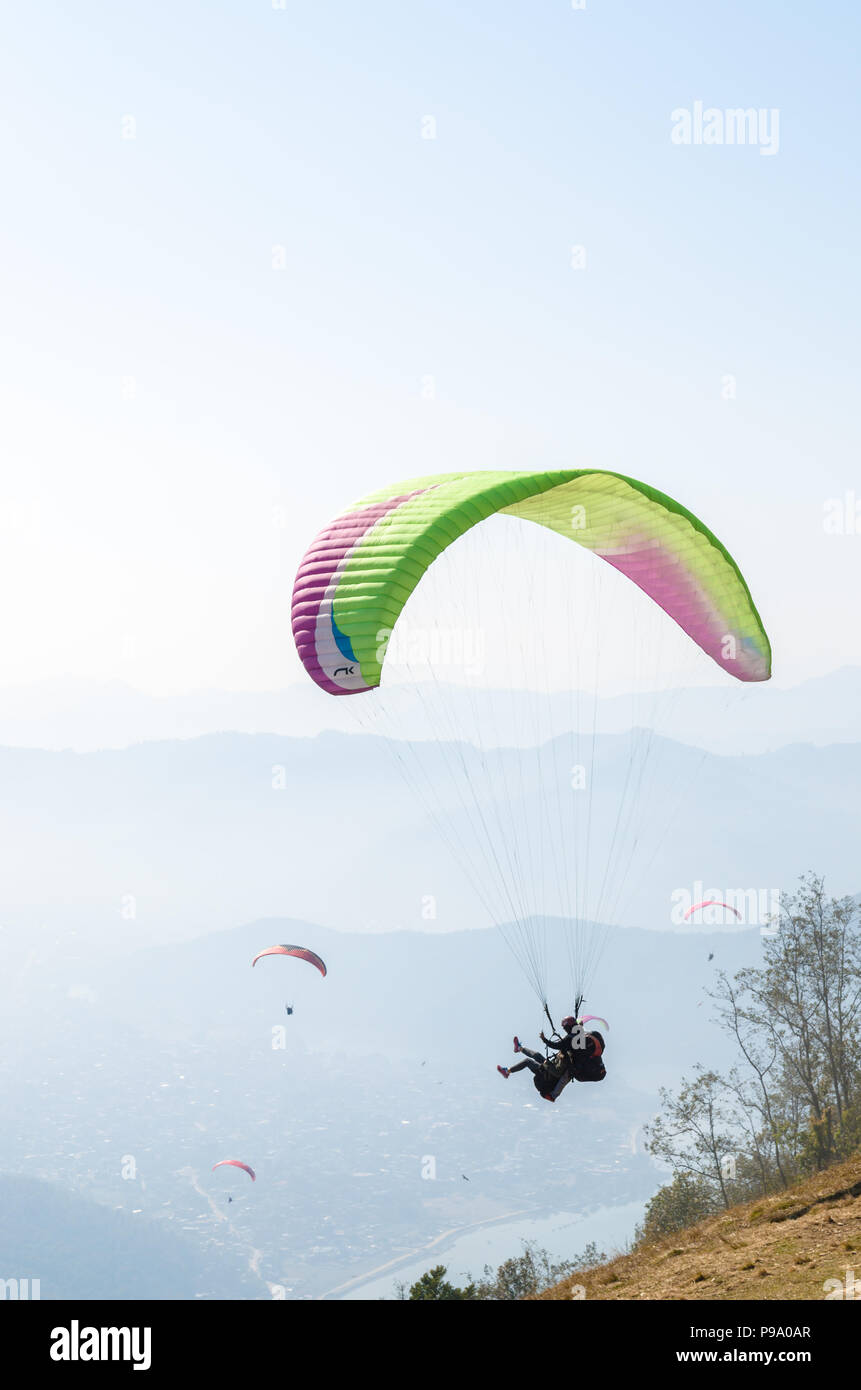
{"left": 0, "top": 667, "right": 861, "bottom": 753}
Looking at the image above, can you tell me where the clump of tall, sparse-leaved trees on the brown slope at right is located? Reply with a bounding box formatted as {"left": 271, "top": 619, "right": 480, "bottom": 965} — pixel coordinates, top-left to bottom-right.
{"left": 640, "top": 874, "right": 861, "bottom": 1238}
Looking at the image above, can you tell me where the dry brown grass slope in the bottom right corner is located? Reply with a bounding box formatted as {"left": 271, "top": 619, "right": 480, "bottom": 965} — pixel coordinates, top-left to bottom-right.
{"left": 538, "top": 1158, "right": 861, "bottom": 1301}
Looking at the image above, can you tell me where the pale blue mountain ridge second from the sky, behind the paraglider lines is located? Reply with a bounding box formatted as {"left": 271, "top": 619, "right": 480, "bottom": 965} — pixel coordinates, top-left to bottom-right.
{"left": 0, "top": 733, "right": 861, "bottom": 948}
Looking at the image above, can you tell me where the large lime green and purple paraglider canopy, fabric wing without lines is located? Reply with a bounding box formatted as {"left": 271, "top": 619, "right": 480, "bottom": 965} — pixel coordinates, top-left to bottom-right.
{"left": 292, "top": 468, "right": 771, "bottom": 695}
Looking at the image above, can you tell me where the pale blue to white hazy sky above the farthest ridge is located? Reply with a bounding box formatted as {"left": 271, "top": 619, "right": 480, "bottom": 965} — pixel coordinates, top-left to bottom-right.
{"left": 0, "top": 0, "right": 861, "bottom": 692}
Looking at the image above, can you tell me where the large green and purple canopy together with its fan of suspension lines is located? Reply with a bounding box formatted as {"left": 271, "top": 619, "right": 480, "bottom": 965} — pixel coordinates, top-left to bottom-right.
{"left": 290, "top": 468, "right": 771, "bottom": 1023}
